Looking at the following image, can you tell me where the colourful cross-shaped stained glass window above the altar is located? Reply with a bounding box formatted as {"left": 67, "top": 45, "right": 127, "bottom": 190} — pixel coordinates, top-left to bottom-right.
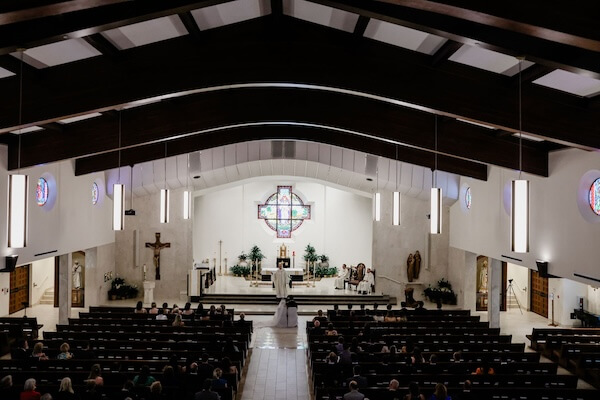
{"left": 258, "top": 186, "right": 310, "bottom": 238}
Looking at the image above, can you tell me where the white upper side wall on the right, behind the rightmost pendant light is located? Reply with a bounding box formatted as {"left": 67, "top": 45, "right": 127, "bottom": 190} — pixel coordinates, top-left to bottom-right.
{"left": 450, "top": 149, "right": 600, "bottom": 284}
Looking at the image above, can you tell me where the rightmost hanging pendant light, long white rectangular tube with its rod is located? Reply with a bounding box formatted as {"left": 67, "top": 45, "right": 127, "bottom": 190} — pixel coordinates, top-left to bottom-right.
{"left": 510, "top": 58, "right": 529, "bottom": 253}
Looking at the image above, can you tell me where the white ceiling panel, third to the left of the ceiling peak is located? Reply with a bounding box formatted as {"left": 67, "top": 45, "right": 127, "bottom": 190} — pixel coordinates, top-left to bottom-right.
{"left": 18, "top": 39, "right": 102, "bottom": 68}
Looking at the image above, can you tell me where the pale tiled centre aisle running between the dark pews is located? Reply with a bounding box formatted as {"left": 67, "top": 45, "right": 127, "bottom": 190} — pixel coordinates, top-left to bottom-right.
{"left": 238, "top": 316, "right": 310, "bottom": 400}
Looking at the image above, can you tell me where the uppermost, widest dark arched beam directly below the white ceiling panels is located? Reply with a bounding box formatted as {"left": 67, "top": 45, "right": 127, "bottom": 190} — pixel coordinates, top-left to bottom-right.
{"left": 0, "top": 16, "right": 600, "bottom": 152}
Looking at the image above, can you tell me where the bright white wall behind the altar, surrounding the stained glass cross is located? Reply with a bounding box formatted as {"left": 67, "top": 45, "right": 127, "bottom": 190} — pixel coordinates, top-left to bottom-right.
{"left": 193, "top": 177, "right": 372, "bottom": 267}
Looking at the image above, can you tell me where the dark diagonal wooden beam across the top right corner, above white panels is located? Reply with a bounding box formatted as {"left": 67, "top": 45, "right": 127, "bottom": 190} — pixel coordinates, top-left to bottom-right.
{"left": 310, "top": 0, "right": 600, "bottom": 79}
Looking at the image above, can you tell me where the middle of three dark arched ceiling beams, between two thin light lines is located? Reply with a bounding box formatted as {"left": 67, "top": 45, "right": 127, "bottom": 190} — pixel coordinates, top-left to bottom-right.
{"left": 9, "top": 88, "right": 548, "bottom": 176}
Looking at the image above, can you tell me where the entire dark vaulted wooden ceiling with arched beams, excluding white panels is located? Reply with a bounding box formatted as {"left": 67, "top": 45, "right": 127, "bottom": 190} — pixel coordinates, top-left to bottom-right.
{"left": 0, "top": 0, "right": 600, "bottom": 179}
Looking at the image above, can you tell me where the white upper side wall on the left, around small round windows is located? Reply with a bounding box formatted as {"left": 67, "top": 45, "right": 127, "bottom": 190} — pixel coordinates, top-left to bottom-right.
{"left": 0, "top": 146, "right": 115, "bottom": 315}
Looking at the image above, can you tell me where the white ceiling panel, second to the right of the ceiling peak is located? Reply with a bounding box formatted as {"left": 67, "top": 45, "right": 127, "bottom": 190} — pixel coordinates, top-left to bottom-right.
{"left": 364, "top": 19, "right": 446, "bottom": 55}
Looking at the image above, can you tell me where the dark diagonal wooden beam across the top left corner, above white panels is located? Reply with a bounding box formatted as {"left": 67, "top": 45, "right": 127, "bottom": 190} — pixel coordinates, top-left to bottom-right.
{"left": 0, "top": 0, "right": 232, "bottom": 55}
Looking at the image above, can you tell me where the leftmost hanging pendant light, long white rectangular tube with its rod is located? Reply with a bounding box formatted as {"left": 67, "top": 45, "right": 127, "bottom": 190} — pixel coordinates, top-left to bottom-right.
{"left": 8, "top": 49, "right": 29, "bottom": 248}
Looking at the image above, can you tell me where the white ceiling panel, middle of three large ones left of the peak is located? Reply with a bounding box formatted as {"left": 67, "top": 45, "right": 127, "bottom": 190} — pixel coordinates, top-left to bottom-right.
{"left": 102, "top": 15, "right": 188, "bottom": 50}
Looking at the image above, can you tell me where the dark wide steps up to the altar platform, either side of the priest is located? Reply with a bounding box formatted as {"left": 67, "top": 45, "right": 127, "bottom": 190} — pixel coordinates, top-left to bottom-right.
{"left": 191, "top": 294, "right": 397, "bottom": 306}
